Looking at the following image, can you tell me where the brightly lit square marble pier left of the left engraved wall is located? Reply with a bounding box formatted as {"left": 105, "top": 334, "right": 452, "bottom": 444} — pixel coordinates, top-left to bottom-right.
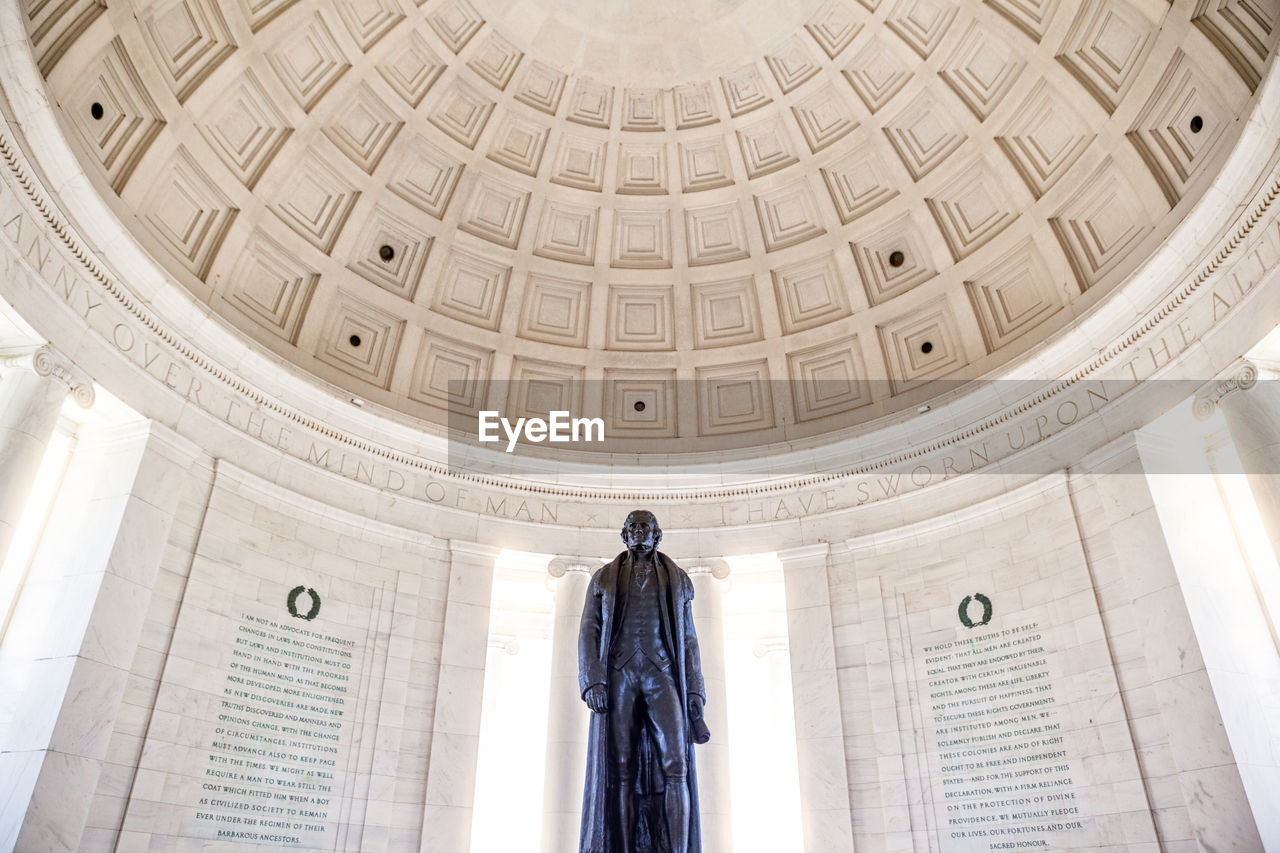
{"left": 0, "top": 419, "right": 189, "bottom": 850}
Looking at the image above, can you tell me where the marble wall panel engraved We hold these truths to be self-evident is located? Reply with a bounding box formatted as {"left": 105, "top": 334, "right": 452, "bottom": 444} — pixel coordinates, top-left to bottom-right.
{"left": 831, "top": 475, "right": 1152, "bottom": 853}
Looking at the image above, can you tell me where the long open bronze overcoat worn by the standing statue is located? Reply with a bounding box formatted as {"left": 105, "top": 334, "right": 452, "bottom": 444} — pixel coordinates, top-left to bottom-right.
{"left": 577, "top": 551, "right": 707, "bottom": 853}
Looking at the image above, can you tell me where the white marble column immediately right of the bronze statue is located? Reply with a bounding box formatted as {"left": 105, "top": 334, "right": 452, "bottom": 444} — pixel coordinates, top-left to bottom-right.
{"left": 684, "top": 560, "right": 733, "bottom": 853}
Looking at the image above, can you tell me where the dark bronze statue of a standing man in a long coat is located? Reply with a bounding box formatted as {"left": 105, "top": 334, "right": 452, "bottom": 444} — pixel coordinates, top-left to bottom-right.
{"left": 577, "top": 510, "right": 710, "bottom": 853}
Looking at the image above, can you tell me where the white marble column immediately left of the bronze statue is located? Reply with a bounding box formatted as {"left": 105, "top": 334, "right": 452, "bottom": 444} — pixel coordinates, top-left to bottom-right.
{"left": 541, "top": 557, "right": 600, "bottom": 853}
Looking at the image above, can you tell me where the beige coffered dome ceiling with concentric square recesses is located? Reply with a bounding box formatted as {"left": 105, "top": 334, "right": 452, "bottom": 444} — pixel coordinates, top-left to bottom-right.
{"left": 27, "top": 0, "right": 1280, "bottom": 450}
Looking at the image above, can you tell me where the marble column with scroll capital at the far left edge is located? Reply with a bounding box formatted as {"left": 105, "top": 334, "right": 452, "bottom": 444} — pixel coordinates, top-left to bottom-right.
{"left": 0, "top": 346, "right": 93, "bottom": 561}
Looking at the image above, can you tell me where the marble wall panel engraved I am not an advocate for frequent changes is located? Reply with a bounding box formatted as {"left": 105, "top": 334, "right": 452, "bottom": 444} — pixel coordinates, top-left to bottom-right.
{"left": 122, "top": 464, "right": 448, "bottom": 850}
